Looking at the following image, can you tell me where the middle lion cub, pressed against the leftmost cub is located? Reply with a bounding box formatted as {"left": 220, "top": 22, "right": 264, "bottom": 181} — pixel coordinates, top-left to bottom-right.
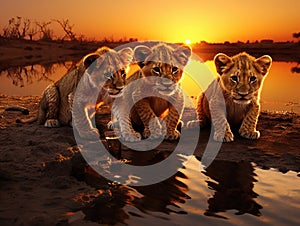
{"left": 112, "top": 43, "right": 191, "bottom": 142}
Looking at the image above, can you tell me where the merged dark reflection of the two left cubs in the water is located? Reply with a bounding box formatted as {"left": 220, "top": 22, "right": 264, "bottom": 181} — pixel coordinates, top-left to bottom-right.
{"left": 81, "top": 164, "right": 190, "bottom": 225}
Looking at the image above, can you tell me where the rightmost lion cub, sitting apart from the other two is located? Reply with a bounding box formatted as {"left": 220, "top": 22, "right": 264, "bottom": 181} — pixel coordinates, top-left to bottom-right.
{"left": 187, "top": 53, "right": 272, "bottom": 142}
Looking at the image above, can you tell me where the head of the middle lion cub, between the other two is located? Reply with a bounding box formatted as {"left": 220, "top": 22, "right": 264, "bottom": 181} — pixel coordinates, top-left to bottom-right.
{"left": 134, "top": 43, "right": 191, "bottom": 96}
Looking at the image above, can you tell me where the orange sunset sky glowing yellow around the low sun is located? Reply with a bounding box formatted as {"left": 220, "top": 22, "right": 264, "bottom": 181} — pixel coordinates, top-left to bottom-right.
{"left": 0, "top": 0, "right": 300, "bottom": 42}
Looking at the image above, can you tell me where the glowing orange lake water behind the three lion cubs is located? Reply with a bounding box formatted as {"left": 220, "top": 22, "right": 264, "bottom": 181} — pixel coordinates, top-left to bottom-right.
{"left": 0, "top": 61, "right": 300, "bottom": 113}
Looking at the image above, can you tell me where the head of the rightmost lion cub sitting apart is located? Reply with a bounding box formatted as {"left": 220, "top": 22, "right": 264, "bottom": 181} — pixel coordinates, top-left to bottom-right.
{"left": 214, "top": 53, "right": 272, "bottom": 104}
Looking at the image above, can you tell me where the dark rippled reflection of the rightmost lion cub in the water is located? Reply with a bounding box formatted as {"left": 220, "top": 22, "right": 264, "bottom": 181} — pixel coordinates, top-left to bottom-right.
{"left": 203, "top": 161, "right": 262, "bottom": 219}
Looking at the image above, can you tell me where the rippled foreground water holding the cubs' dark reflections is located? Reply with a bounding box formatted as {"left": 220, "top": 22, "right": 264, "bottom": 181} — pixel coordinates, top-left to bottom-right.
{"left": 79, "top": 157, "right": 300, "bottom": 226}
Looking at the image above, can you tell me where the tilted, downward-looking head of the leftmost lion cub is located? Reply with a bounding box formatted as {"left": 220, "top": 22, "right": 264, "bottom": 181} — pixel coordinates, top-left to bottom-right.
{"left": 84, "top": 47, "right": 133, "bottom": 97}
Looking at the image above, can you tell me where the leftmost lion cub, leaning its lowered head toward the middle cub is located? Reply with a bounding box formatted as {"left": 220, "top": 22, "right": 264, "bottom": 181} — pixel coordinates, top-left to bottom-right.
{"left": 24, "top": 47, "right": 133, "bottom": 137}
